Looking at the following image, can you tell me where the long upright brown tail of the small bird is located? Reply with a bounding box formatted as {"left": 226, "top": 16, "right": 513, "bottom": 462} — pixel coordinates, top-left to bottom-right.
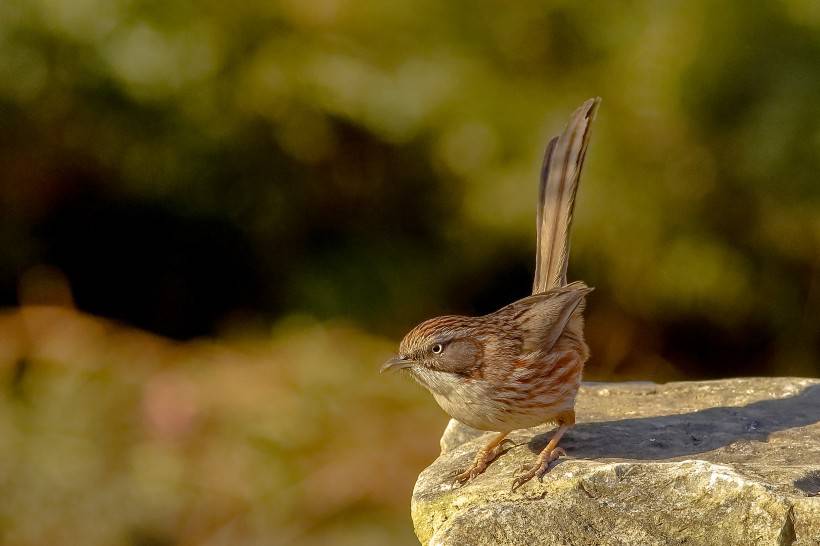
{"left": 532, "top": 97, "right": 601, "bottom": 294}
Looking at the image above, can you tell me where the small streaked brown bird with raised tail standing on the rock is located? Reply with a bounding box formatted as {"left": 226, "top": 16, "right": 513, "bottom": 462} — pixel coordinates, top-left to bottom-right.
{"left": 382, "top": 98, "right": 601, "bottom": 489}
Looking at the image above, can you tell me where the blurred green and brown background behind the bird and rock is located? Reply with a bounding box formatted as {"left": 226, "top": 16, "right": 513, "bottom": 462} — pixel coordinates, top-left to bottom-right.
{"left": 0, "top": 0, "right": 820, "bottom": 546}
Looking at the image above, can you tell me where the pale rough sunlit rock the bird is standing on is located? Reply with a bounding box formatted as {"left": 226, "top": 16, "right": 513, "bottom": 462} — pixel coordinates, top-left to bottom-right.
{"left": 412, "top": 378, "right": 820, "bottom": 546}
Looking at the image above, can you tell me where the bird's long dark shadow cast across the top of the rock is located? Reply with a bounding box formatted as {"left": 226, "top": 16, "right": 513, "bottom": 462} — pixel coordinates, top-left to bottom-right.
{"left": 528, "top": 385, "right": 820, "bottom": 460}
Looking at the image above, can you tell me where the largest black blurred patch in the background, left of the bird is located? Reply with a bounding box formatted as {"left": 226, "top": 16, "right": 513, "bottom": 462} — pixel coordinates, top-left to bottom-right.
{"left": 35, "top": 190, "right": 262, "bottom": 339}
